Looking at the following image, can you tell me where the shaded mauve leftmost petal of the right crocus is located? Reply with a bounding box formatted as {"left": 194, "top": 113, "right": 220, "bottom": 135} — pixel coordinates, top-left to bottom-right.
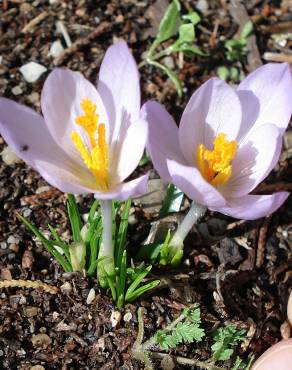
{"left": 141, "top": 101, "right": 186, "bottom": 182}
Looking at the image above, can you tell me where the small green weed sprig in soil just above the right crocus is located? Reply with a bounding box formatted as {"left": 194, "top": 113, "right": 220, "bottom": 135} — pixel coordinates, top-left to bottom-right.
{"left": 217, "top": 21, "right": 253, "bottom": 82}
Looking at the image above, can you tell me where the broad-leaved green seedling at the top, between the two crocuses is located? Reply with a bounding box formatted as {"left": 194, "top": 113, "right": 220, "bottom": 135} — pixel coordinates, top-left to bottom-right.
{"left": 139, "top": 0, "right": 206, "bottom": 96}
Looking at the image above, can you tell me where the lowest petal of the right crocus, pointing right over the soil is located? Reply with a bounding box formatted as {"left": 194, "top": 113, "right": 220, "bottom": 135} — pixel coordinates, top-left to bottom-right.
{"left": 211, "top": 191, "right": 289, "bottom": 220}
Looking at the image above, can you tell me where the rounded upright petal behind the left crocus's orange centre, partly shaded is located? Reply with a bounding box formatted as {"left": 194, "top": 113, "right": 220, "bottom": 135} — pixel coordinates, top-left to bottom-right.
{"left": 41, "top": 68, "right": 109, "bottom": 158}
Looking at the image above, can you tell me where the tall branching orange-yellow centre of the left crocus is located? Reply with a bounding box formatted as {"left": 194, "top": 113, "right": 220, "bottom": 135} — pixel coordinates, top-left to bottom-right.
{"left": 71, "top": 98, "right": 109, "bottom": 191}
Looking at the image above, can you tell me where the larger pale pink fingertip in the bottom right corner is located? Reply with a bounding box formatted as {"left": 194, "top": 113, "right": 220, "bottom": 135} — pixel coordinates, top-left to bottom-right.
{"left": 251, "top": 339, "right": 292, "bottom": 370}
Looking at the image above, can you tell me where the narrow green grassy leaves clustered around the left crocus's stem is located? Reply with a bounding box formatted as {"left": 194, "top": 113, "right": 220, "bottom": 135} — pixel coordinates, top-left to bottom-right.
{"left": 18, "top": 194, "right": 159, "bottom": 308}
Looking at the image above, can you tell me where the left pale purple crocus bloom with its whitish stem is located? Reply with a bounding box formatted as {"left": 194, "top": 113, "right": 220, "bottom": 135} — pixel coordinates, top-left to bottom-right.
{"left": 0, "top": 42, "right": 148, "bottom": 278}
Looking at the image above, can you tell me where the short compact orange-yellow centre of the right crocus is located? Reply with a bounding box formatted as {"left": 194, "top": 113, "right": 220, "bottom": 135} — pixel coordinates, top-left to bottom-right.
{"left": 197, "top": 133, "right": 237, "bottom": 186}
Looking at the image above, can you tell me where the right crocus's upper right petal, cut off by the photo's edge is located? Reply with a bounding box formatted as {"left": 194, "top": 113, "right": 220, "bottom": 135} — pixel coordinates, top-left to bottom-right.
{"left": 237, "top": 63, "right": 292, "bottom": 137}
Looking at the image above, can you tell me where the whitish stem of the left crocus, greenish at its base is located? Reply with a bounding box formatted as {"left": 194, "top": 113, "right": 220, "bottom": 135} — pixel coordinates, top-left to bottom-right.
{"left": 97, "top": 200, "right": 115, "bottom": 286}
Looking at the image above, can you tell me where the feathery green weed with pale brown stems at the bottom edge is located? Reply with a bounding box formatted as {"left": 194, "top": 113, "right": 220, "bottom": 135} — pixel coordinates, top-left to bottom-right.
{"left": 132, "top": 304, "right": 253, "bottom": 370}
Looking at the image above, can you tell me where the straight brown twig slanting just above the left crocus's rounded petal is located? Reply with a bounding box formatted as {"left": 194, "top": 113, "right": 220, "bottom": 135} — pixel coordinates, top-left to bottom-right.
{"left": 54, "top": 22, "right": 111, "bottom": 66}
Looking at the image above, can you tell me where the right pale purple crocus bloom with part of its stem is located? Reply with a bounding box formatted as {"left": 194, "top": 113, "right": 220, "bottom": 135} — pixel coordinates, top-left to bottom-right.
{"left": 142, "top": 63, "right": 292, "bottom": 260}
